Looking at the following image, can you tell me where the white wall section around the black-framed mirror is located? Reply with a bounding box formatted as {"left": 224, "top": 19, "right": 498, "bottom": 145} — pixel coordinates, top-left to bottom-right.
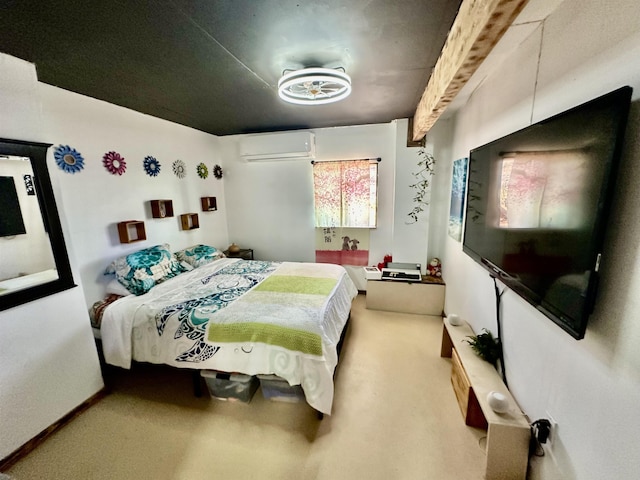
{"left": 0, "top": 54, "right": 103, "bottom": 458}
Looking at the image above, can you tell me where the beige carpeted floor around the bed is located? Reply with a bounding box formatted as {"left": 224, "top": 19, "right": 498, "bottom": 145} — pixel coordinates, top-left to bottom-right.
{"left": 5, "top": 295, "right": 485, "bottom": 480}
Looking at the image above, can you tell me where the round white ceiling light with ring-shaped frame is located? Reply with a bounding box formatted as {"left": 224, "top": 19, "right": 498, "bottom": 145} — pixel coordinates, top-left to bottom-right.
{"left": 278, "top": 67, "right": 351, "bottom": 105}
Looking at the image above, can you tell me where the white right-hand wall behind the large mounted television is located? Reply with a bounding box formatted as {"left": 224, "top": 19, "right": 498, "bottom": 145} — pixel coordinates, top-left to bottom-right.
{"left": 431, "top": 0, "right": 640, "bottom": 479}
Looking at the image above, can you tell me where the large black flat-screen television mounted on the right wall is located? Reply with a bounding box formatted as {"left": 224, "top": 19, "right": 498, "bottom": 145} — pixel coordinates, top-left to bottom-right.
{"left": 463, "top": 87, "right": 632, "bottom": 339}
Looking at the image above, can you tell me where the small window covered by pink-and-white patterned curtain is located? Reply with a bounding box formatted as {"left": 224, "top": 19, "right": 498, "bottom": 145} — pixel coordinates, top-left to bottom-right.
{"left": 313, "top": 159, "right": 378, "bottom": 228}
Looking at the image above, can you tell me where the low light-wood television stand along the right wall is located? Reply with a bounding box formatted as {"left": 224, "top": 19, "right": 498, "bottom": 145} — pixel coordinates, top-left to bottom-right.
{"left": 440, "top": 319, "right": 531, "bottom": 480}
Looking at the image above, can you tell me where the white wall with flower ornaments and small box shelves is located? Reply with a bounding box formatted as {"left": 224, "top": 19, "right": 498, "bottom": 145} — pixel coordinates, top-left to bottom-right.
{"left": 37, "top": 83, "right": 228, "bottom": 306}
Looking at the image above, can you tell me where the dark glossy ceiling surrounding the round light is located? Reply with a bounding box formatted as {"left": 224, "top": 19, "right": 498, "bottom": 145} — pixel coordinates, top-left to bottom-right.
{"left": 0, "top": 0, "right": 461, "bottom": 135}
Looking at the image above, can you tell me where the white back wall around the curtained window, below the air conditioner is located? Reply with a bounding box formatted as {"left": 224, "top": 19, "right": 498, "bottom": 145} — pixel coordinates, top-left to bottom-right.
{"left": 219, "top": 122, "right": 396, "bottom": 270}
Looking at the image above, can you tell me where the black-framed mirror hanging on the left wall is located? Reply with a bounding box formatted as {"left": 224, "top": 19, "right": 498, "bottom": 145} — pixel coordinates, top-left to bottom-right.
{"left": 0, "top": 139, "right": 75, "bottom": 310}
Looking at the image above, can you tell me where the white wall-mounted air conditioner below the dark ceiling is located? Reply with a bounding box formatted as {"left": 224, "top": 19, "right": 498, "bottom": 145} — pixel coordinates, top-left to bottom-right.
{"left": 240, "top": 132, "right": 316, "bottom": 162}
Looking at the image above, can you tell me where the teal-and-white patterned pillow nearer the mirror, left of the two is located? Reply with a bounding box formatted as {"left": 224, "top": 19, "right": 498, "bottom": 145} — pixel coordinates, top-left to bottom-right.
{"left": 106, "top": 243, "right": 186, "bottom": 295}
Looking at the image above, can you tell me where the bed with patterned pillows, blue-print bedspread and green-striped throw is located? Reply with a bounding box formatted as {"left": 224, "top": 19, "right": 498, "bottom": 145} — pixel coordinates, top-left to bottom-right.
{"left": 92, "top": 245, "right": 357, "bottom": 414}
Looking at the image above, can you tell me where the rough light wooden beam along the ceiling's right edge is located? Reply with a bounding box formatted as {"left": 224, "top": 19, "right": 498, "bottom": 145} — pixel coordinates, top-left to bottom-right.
{"left": 413, "top": 0, "right": 529, "bottom": 141}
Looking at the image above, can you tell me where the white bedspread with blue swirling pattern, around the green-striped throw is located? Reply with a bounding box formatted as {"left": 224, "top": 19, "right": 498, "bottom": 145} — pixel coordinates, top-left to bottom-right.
{"left": 101, "top": 258, "right": 357, "bottom": 414}
